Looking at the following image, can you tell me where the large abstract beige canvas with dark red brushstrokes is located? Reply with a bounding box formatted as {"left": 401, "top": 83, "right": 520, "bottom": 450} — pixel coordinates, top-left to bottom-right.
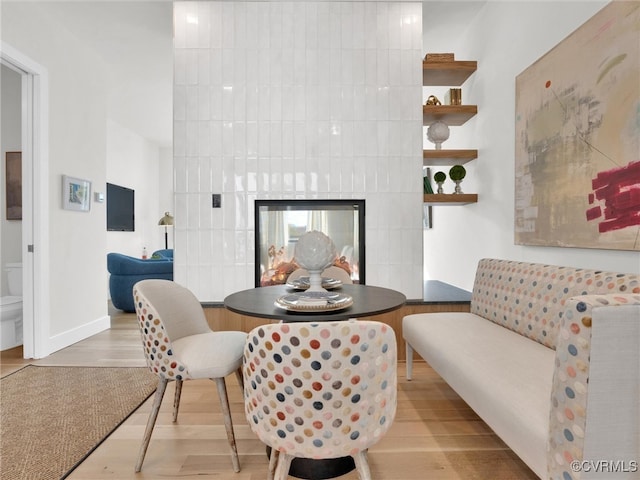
{"left": 515, "top": 2, "right": 640, "bottom": 250}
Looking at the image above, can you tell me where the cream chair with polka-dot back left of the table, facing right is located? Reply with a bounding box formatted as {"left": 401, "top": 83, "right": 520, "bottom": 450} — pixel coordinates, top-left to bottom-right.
{"left": 133, "top": 280, "right": 247, "bottom": 472}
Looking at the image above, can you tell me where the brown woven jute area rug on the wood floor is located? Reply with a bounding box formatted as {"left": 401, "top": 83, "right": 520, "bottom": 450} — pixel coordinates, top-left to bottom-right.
{"left": 0, "top": 365, "right": 158, "bottom": 480}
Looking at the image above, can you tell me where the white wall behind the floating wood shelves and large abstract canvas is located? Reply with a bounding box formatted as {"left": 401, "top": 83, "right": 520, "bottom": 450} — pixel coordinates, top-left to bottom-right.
{"left": 423, "top": 1, "right": 640, "bottom": 289}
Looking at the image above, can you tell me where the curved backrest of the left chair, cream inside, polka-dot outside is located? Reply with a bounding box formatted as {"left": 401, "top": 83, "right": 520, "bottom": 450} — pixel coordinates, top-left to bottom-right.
{"left": 133, "top": 279, "right": 210, "bottom": 380}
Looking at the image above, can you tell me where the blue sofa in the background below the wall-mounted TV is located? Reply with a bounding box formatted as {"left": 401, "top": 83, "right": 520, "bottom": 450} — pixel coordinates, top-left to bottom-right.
{"left": 107, "top": 249, "right": 173, "bottom": 312}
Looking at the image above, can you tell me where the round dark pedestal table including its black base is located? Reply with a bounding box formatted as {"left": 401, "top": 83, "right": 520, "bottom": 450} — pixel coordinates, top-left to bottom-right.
{"left": 224, "top": 284, "right": 407, "bottom": 480}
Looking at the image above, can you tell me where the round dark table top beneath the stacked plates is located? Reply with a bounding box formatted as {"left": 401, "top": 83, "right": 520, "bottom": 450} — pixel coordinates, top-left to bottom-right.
{"left": 224, "top": 284, "right": 406, "bottom": 322}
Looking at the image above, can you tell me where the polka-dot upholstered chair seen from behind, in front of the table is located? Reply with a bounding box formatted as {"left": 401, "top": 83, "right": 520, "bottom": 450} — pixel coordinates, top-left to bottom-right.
{"left": 243, "top": 320, "right": 397, "bottom": 480}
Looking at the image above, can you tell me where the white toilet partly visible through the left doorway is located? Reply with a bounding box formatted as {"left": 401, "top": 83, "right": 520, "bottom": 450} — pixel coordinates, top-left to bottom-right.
{"left": 0, "top": 263, "right": 22, "bottom": 350}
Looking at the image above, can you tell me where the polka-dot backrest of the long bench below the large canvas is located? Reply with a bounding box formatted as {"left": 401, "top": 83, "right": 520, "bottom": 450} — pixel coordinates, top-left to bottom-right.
{"left": 471, "top": 258, "right": 640, "bottom": 349}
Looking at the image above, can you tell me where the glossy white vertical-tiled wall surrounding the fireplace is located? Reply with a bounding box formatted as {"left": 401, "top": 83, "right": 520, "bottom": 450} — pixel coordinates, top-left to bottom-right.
{"left": 174, "top": 1, "right": 423, "bottom": 302}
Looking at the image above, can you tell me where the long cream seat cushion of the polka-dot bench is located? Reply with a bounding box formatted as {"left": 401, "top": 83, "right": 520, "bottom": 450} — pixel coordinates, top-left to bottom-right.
{"left": 402, "top": 312, "right": 554, "bottom": 478}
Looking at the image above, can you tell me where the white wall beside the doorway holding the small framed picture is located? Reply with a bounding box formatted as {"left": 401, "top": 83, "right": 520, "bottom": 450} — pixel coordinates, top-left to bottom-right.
{"left": 2, "top": 2, "right": 106, "bottom": 344}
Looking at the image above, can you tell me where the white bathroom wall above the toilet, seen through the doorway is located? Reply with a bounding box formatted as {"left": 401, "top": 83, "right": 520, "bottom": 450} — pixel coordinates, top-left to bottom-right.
{"left": 0, "top": 65, "right": 22, "bottom": 296}
